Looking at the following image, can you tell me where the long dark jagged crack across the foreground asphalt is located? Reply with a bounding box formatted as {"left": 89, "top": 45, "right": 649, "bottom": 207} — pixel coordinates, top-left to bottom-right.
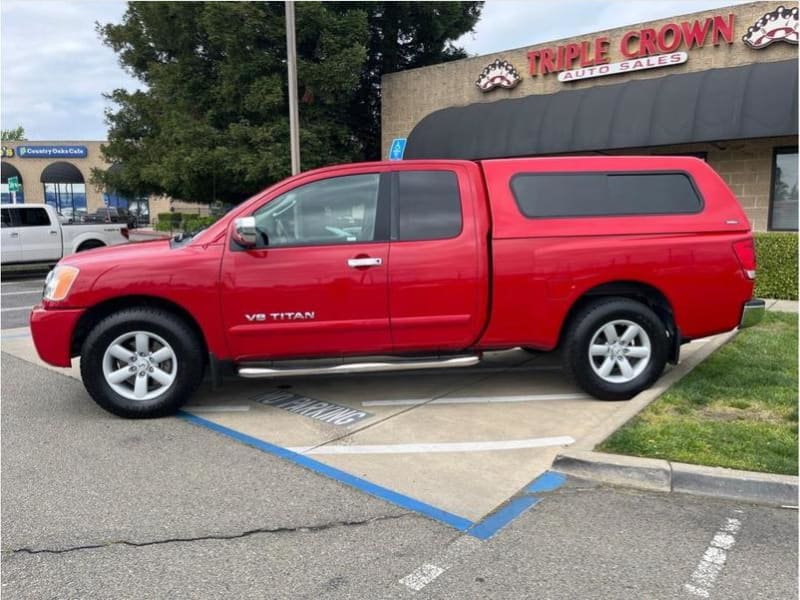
{"left": 3, "top": 512, "right": 413, "bottom": 555}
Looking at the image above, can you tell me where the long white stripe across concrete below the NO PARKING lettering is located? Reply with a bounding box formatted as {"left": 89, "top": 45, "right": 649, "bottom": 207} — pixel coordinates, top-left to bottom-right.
{"left": 289, "top": 435, "right": 575, "bottom": 454}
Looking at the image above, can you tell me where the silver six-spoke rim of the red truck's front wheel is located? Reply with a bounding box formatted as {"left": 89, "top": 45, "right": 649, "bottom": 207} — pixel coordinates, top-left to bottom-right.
{"left": 103, "top": 331, "right": 178, "bottom": 401}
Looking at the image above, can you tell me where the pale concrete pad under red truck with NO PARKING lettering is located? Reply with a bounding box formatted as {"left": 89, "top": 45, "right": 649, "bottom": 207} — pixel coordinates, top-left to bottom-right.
{"left": 3, "top": 291, "right": 724, "bottom": 533}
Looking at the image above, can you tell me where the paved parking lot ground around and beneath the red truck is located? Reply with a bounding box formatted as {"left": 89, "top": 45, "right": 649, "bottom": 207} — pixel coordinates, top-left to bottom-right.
{"left": 2, "top": 279, "right": 797, "bottom": 599}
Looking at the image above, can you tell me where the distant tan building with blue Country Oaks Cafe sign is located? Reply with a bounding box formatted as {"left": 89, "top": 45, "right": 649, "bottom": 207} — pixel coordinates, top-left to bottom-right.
{"left": 0, "top": 141, "right": 209, "bottom": 225}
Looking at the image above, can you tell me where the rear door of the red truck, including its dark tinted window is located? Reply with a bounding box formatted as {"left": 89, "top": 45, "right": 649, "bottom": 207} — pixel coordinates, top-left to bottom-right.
{"left": 389, "top": 165, "right": 489, "bottom": 351}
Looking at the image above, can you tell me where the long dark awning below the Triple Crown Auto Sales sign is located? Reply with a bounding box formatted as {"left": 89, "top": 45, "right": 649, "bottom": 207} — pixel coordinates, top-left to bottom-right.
{"left": 405, "top": 60, "right": 797, "bottom": 159}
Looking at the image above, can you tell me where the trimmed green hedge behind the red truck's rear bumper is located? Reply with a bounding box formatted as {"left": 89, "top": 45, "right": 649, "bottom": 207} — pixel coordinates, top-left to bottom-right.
{"left": 755, "top": 232, "right": 797, "bottom": 300}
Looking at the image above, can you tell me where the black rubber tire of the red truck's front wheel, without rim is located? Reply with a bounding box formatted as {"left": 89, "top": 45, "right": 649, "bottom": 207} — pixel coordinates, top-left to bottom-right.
{"left": 81, "top": 308, "right": 205, "bottom": 419}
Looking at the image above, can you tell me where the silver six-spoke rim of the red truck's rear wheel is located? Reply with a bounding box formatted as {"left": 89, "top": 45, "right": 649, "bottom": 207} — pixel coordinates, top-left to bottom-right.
{"left": 589, "top": 319, "right": 652, "bottom": 383}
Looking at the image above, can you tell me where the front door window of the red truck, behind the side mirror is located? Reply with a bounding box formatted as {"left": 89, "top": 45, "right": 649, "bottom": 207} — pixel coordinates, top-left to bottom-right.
{"left": 253, "top": 173, "right": 380, "bottom": 248}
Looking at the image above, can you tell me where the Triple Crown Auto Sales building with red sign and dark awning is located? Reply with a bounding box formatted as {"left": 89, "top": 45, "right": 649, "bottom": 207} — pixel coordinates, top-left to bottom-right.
{"left": 382, "top": 2, "right": 798, "bottom": 231}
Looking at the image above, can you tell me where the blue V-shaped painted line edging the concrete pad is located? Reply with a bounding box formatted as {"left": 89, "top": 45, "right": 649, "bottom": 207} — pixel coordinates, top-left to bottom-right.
{"left": 178, "top": 411, "right": 566, "bottom": 540}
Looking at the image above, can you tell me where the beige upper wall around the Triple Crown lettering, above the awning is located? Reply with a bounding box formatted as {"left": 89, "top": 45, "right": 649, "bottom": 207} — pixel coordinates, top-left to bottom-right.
{"left": 381, "top": 2, "right": 798, "bottom": 152}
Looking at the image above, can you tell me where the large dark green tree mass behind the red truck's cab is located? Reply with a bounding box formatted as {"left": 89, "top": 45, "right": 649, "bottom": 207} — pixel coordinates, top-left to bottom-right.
{"left": 93, "top": 2, "right": 481, "bottom": 201}
